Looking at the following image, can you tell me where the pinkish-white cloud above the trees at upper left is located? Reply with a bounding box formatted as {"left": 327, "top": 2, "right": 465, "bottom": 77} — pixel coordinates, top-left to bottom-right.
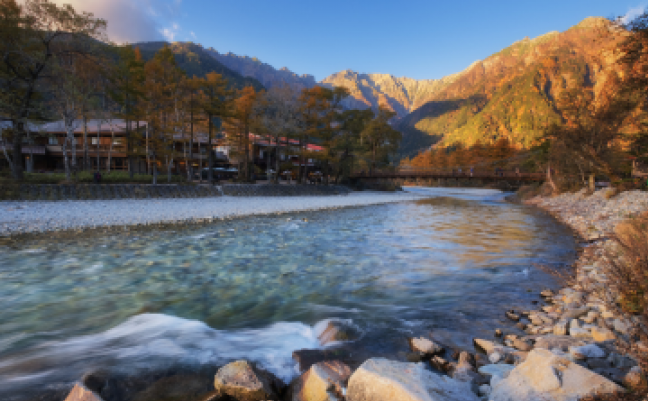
{"left": 50, "top": 0, "right": 182, "bottom": 43}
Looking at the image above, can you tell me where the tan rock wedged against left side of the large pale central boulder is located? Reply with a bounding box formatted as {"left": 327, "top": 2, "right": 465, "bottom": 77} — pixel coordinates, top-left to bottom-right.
{"left": 290, "top": 361, "right": 351, "bottom": 401}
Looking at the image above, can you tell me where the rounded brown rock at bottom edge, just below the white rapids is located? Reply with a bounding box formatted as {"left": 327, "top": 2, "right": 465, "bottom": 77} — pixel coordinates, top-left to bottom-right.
{"left": 214, "top": 361, "right": 281, "bottom": 401}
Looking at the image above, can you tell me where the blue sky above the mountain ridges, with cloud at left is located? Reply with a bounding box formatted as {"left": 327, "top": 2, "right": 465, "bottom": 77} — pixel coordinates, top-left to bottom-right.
{"left": 53, "top": 0, "right": 648, "bottom": 80}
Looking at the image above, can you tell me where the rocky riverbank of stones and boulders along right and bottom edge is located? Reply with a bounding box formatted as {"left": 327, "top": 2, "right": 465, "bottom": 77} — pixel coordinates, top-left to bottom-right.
{"left": 46, "top": 190, "right": 648, "bottom": 401}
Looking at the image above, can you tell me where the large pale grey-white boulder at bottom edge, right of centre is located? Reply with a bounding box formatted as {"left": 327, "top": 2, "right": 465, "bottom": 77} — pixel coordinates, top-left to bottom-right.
{"left": 347, "top": 358, "right": 479, "bottom": 401}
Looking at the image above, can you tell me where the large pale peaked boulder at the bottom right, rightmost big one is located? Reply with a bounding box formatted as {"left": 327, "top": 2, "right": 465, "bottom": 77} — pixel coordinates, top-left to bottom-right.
{"left": 489, "top": 349, "right": 623, "bottom": 401}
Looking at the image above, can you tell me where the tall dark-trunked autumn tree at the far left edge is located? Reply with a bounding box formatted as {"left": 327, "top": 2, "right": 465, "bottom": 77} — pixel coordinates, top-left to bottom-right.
{"left": 0, "top": 0, "right": 106, "bottom": 180}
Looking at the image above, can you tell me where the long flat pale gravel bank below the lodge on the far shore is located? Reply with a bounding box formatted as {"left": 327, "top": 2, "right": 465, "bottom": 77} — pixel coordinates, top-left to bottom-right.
{"left": 0, "top": 192, "right": 424, "bottom": 236}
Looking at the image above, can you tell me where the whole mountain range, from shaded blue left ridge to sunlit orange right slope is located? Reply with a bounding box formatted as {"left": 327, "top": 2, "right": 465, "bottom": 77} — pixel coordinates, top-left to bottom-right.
{"left": 135, "top": 17, "right": 619, "bottom": 156}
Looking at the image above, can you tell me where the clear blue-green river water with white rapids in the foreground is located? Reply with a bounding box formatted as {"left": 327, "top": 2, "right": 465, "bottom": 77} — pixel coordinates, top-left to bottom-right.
{"left": 0, "top": 188, "right": 576, "bottom": 399}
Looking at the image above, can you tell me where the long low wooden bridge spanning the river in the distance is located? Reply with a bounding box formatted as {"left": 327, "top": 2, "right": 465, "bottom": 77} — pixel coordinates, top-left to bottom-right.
{"left": 350, "top": 168, "right": 546, "bottom": 182}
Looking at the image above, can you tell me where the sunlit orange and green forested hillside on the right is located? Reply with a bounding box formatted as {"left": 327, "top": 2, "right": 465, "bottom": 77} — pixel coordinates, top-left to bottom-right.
{"left": 399, "top": 18, "right": 618, "bottom": 155}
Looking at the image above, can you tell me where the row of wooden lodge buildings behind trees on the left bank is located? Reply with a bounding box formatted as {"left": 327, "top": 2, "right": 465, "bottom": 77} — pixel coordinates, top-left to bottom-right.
{"left": 0, "top": 119, "right": 323, "bottom": 174}
